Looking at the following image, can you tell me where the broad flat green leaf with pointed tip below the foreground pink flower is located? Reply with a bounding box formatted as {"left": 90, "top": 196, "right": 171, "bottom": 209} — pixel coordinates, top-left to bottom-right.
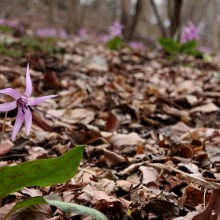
{"left": 0, "top": 146, "right": 84, "bottom": 198}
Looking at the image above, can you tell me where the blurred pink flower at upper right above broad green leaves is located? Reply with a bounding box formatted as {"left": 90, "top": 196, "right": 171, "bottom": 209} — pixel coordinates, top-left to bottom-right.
{"left": 180, "top": 22, "right": 199, "bottom": 43}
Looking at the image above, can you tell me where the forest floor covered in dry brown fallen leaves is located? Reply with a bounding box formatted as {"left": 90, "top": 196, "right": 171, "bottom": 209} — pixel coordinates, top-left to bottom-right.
{"left": 0, "top": 33, "right": 220, "bottom": 220}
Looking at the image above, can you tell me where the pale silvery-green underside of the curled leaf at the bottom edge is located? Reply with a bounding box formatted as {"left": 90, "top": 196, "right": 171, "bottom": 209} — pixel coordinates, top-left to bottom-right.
{"left": 45, "top": 199, "right": 108, "bottom": 220}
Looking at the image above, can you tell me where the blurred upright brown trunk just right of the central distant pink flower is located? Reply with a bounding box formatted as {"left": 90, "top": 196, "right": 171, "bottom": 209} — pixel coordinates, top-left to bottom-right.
{"left": 121, "top": 0, "right": 131, "bottom": 38}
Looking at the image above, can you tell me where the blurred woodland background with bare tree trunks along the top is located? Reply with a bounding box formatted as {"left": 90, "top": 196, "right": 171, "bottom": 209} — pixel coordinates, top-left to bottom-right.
{"left": 0, "top": 0, "right": 220, "bottom": 52}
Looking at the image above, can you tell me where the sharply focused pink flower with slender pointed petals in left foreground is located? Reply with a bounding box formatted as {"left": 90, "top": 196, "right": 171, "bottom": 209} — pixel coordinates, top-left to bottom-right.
{"left": 0, "top": 64, "right": 57, "bottom": 141}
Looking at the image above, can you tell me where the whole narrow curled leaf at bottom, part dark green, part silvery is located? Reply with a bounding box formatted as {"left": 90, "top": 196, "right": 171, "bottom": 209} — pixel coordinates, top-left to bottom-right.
{"left": 2, "top": 196, "right": 108, "bottom": 220}
